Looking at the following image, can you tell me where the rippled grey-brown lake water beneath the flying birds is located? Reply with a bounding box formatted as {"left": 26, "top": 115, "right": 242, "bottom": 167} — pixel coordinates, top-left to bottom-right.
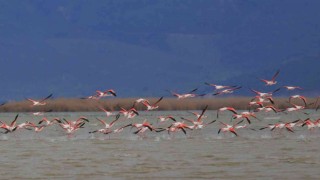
{"left": 0, "top": 111, "right": 320, "bottom": 179}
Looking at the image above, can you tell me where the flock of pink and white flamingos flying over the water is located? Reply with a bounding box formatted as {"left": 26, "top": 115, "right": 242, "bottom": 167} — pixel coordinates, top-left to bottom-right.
{"left": 0, "top": 70, "right": 320, "bottom": 137}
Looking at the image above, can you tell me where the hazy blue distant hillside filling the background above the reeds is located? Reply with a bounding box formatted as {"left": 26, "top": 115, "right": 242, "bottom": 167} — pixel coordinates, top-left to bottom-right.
{"left": 0, "top": 0, "right": 320, "bottom": 100}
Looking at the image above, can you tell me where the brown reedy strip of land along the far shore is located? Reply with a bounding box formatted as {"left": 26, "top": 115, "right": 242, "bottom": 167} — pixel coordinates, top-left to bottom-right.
{"left": 0, "top": 97, "right": 316, "bottom": 112}
